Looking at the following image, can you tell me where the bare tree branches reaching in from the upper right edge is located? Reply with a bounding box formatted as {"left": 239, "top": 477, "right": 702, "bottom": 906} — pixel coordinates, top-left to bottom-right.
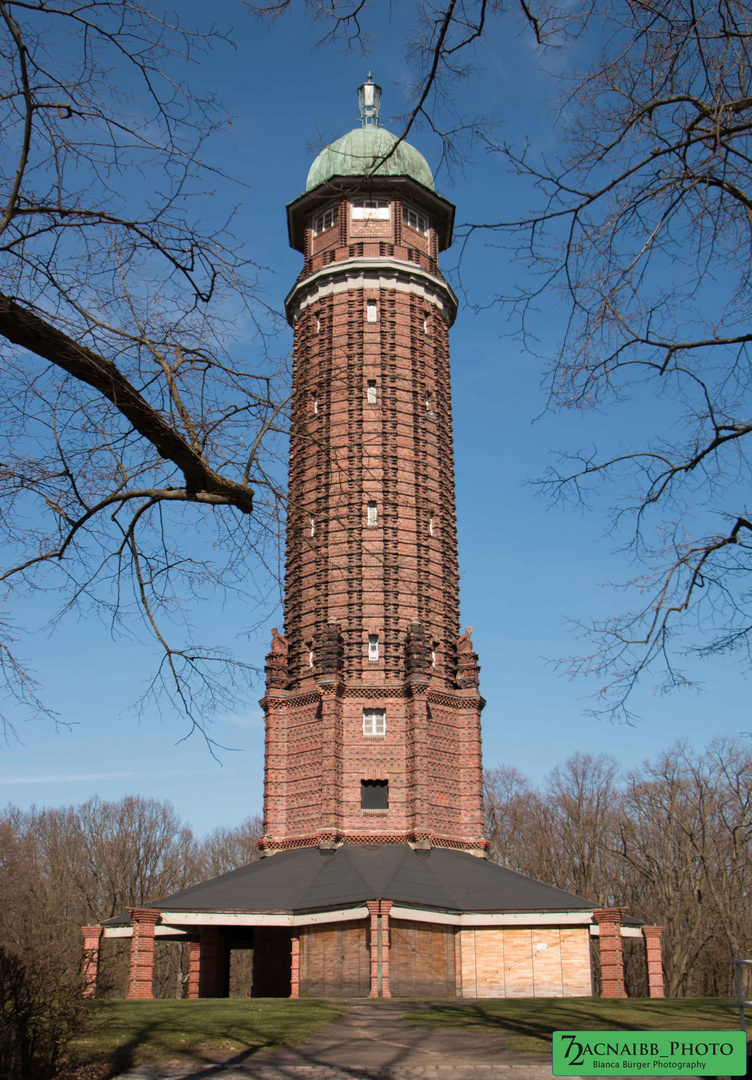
{"left": 470, "top": 0, "right": 752, "bottom": 716}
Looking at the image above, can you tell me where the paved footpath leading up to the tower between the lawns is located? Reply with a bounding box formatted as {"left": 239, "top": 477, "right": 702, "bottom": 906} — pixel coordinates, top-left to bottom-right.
{"left": 112, "top": 1000, "right": 708, "bottom": 1080}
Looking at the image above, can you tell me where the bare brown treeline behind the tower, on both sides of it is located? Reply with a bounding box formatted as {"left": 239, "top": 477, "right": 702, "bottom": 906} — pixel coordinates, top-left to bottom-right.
{"left": 0, "top": 740, "right": 752, "bottom": 997}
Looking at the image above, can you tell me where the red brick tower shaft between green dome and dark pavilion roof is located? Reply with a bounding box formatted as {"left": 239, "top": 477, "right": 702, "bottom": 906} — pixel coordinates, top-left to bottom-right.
{"left": 263, "top": 128, "right": 485, "bottom": 852}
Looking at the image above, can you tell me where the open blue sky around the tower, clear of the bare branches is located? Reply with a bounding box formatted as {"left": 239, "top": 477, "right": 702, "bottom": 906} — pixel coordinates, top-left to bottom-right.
{"left": 0, "top": 2, "right": 751, "bottom": 834}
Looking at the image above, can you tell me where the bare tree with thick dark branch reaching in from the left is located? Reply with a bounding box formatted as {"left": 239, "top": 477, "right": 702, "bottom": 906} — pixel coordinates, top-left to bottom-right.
{"left": 0, "top": 0, "right": 283, "bottom": 738}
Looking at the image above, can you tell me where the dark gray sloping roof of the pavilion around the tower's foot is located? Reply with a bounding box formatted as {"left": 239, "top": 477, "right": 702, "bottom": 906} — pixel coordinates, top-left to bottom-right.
{"left": 105, "top": 843, "right": 597, "bottom": 926}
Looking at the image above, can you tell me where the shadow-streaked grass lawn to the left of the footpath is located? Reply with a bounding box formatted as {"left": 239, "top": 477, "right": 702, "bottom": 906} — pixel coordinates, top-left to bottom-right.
{"left": 71, "top": 998, "right": 343, "bottom": 1076}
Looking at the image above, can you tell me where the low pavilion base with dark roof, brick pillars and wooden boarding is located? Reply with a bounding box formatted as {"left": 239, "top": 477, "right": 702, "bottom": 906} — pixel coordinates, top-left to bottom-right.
{"left": 90, "top": 842, "right": 662, "bottom": 998}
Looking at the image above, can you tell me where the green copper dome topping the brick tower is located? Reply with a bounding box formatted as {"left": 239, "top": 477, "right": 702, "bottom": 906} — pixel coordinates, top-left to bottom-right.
{"left": 306, "top": 124, "right": 434, "bottom": 191}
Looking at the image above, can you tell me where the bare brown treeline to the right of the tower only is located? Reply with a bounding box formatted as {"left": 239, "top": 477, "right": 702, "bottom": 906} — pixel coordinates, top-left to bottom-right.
{"left": 485, "top": 739, "right": 752, "bottom": 997}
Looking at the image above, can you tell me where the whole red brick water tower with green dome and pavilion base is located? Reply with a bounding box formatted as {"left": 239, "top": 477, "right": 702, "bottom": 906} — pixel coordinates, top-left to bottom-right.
{"left": 83, "top": 77, "right": 662, "bottom": 998}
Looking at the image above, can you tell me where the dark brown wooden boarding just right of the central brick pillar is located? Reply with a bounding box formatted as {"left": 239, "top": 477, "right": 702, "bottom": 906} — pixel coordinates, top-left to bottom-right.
{"left": 389, "top": 919, "right": 457, "bottom": 998}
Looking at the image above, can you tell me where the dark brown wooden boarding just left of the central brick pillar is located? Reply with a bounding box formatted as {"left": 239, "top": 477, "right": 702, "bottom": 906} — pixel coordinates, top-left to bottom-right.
{"left": 300, "top": 920, "right": 371, "bottom": 998}
